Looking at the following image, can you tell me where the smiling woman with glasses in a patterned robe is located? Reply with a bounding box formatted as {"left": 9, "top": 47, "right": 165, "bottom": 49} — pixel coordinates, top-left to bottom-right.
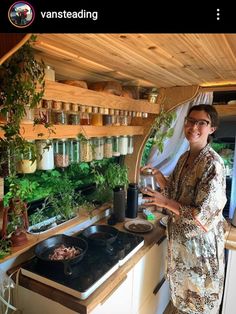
{"left": 141, "top": 105, "right": 226, "bottom": 314}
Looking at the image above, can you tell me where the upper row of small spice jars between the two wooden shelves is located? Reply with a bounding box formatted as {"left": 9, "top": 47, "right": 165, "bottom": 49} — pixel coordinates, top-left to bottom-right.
{"left": 22, "top": 100, "right": 148, "bottom": 126}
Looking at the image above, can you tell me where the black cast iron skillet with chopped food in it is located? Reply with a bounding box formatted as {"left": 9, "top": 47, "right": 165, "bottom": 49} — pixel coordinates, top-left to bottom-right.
{"left": 35, "top": 234, "right": 88, "bottom": 275}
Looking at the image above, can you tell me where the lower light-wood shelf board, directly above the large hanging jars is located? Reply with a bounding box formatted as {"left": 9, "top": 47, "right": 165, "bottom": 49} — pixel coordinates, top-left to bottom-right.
{"left": 0, "top": 124, "right": 144, "bottom": 140}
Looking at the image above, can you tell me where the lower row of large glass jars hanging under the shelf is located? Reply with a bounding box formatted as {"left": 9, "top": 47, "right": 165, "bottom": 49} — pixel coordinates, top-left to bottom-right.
{"left": 17, "top": 136, "right": 133, "bottom": 173}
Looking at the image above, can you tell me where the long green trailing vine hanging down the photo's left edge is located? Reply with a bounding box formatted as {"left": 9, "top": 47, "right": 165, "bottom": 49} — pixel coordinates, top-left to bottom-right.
{"left": 0, "top": 36, "right": 45, "bottom": 247}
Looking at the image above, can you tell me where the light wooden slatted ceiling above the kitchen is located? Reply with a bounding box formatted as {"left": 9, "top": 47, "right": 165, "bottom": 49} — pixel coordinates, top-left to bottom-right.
{"left": 35, "top": 34, "right": 236, "bottom": 87}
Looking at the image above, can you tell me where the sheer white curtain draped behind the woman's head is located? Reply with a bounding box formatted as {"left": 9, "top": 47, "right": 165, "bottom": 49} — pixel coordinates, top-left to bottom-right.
{"left": 148, "top": 92, "right": 213, "bottom": 176}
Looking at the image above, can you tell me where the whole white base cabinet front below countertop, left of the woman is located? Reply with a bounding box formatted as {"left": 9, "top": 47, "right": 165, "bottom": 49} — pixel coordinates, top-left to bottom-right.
{"left": 91, "top": 239, "right": 170, "bottom": 314}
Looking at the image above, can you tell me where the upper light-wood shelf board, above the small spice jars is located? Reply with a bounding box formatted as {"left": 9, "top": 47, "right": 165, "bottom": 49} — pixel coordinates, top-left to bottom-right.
{"left": 43, "top": 81, "right": 160, "bottom": 114}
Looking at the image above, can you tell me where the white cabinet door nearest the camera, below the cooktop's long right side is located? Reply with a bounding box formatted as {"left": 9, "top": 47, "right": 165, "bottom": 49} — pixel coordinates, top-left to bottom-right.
{"left": 91, "top": 270, "right": 133, "bottom": 314}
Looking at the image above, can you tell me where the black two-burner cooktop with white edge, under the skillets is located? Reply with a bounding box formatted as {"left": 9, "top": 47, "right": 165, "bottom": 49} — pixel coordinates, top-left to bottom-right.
{"left": 21, "top": 231, "right": 144, "bottom": 299}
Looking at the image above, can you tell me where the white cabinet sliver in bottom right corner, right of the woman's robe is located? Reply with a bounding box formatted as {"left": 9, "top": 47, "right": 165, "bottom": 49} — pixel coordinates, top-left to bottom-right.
{"left": 222, "top": 250, "right": 236, "bottom": 314}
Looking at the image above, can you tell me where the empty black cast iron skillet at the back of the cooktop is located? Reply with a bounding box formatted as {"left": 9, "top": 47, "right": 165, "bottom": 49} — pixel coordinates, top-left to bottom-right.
{"left": 82, "top": 225, "right": 119, "bottom": 248}
